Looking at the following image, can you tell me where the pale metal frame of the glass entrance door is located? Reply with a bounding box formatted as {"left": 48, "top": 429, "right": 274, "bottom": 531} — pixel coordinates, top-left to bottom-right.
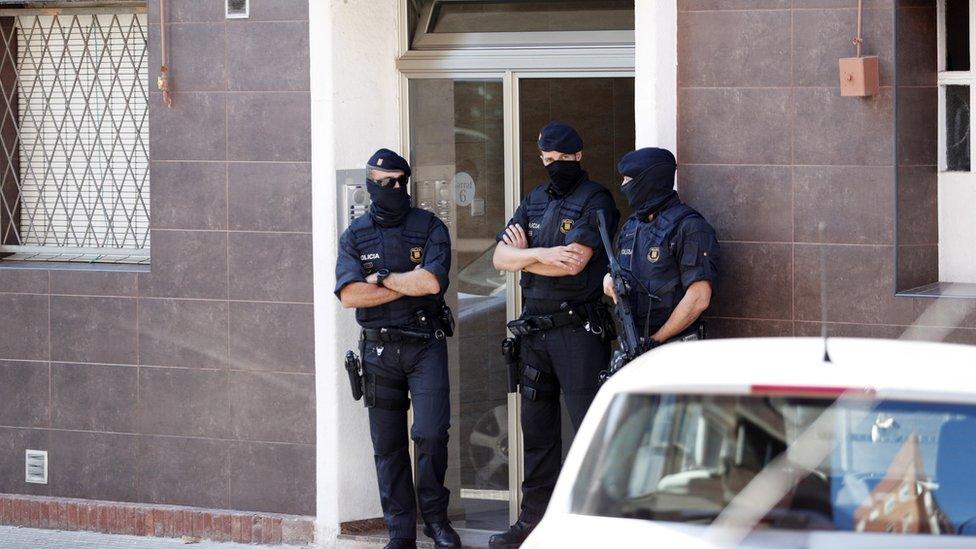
{"left": 396, "top": 1, "right": 636, "bottom": 523}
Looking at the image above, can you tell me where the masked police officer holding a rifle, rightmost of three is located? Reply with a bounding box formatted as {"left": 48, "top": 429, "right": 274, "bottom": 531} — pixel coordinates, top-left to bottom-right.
{"left": 603, "top": 147, "right": 719, "bottom": 350}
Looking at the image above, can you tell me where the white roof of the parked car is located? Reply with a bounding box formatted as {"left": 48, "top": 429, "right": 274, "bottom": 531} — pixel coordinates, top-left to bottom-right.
{"left": 605, "top": 337, "right": 976, "bottom": 402}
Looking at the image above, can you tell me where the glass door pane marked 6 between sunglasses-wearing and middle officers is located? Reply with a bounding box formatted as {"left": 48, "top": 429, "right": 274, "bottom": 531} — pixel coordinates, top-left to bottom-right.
{"left": 409, "top": 79, "right": 510, "bottom": 529}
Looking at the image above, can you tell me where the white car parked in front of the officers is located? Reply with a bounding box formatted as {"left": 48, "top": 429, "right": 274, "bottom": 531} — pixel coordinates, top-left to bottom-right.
{"left": 523, "top": 338, "right": 976, "bottom": 549}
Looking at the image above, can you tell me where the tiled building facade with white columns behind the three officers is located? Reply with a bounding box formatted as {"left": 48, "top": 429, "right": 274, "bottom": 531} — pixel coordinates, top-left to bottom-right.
{"left": 0, "top": 0, "right": 976, "bottom": 544}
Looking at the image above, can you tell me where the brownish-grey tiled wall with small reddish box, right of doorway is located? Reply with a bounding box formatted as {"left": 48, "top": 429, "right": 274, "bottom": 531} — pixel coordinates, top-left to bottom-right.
{"left": 678, "top": 0, "right": 976, "bottom": 343}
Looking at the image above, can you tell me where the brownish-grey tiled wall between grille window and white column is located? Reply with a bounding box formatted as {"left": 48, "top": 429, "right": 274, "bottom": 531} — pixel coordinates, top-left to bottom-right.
{"left": 0, "top": 0, "right": 315, "bottom": 515}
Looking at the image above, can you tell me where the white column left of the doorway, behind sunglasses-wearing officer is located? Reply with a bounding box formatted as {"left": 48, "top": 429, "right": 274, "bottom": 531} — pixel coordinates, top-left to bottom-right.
{"left": 309, "top": 0, "right": 400, "bottom": 547}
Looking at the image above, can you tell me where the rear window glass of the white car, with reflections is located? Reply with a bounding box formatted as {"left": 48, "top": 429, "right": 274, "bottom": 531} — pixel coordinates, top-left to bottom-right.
{"left": 572, "top": 394, "right": 976, "bottom": 535}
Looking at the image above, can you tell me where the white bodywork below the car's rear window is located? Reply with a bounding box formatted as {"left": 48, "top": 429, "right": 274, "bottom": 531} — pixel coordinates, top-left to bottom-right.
{"left": 522, "top": 513, "right": 974, "bottom": 549}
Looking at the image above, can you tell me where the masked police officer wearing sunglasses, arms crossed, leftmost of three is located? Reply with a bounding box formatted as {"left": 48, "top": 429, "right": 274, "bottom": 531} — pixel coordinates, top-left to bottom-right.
{"left": 335, "top": 149, "right": 461, "bottom": 549}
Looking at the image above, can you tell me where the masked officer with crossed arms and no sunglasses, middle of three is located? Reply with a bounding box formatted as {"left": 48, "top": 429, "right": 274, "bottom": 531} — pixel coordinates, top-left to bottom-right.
{"left": 489, "top": 122, "right": 620, "bottom": 548}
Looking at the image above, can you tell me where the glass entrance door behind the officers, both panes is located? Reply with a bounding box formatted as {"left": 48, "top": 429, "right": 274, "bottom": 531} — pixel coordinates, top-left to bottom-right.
{"left": 405, "top": 71, "right": 634, "bottom": 530}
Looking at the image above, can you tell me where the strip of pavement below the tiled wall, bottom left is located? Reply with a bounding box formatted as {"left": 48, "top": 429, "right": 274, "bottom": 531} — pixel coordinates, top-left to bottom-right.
{"left": 0, "top": 526, "right": 300, "bottom": 549}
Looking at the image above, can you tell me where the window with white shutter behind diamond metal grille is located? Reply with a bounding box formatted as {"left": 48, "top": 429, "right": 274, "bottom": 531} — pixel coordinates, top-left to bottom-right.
{"left": 0, "top": 8, "right": 149, "bottom": 263}
